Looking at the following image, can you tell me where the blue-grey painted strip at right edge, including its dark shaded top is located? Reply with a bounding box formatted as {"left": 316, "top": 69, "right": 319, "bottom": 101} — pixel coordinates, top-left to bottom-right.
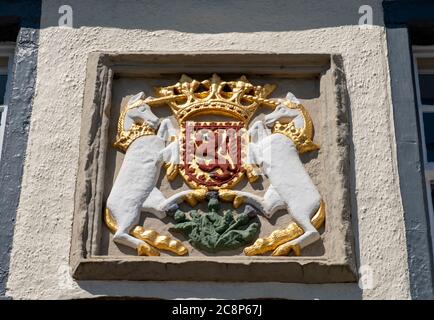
{"left": 383, "top": 0, "right": 434, "bottom": 299}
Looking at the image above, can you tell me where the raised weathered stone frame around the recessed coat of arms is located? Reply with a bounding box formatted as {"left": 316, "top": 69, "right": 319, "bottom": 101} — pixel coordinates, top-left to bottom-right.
{"left": 70, "top": 52, "right": 357, "bottom": 283}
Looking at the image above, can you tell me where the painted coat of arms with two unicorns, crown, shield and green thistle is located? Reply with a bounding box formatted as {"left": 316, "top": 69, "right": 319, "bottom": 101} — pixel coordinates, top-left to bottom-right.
{"left": 104, "top": 74, "right": 325, "bottom": 256}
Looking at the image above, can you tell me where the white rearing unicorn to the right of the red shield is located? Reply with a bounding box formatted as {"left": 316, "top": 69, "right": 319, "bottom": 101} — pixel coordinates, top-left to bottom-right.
{"left": 233, "top": 93, "right": 323, "bottom": 255}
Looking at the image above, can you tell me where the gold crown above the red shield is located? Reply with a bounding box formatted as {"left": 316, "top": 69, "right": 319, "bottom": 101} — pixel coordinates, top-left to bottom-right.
{"left": 155, "top": 74, "right": 276, "bottom": 124}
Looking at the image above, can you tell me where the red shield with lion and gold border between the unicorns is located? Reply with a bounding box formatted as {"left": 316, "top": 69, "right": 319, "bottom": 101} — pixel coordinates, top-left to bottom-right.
{"left": 180, "top": 121, "right": 246, "bottom": 190}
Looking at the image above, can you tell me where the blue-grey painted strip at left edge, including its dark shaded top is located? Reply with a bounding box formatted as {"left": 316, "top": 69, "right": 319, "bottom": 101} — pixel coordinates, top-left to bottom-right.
{"left": 0, "top": 0, "right": 41, "bottom": 298}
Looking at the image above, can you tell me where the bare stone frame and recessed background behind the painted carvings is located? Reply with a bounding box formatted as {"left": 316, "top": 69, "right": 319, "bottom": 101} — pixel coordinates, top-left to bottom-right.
{"left": 71, "top": 53, "right": 356, "bottom": 283}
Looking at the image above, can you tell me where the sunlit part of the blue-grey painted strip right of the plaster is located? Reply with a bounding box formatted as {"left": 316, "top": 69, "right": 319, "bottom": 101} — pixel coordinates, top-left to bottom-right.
{"left": 387, "top": 28, "right": 434, "bottom": 299}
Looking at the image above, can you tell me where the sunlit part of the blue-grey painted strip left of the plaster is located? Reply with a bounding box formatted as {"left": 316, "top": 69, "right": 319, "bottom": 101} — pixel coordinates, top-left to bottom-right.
{"left": 0, "top": 28, "right": 39, "bottom": 296}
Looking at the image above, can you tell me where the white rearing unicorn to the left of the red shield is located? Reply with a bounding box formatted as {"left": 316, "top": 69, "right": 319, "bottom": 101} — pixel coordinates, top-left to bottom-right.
{"left": 105, "top": 92, "right": 197, "bottom": 255}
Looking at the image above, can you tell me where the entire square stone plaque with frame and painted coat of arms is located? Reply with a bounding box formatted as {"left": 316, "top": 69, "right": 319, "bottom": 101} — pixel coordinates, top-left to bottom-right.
{"left": 71, "top": 53, "right": 356, "bottom": 283}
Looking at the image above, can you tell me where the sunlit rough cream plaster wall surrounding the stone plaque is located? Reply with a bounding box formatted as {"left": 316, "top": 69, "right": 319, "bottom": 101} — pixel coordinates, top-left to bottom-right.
{"left": 8, "top": 1, "right": 409, "bottom": 299}
